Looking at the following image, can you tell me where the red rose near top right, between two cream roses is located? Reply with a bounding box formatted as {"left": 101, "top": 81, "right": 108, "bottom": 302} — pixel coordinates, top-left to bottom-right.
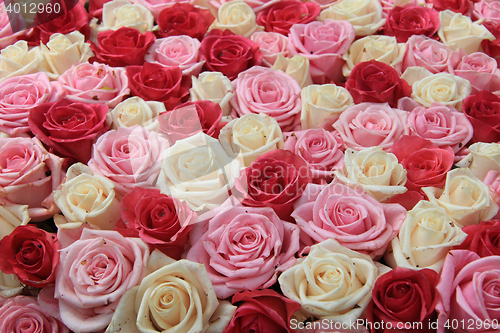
{"left": 384, "top": 6, "right": 441, "bottom": 43}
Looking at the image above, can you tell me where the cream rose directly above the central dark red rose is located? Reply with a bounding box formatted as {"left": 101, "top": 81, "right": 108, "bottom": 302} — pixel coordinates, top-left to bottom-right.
{"left": 219, "top": 113, "right": 283, "bottom": 167}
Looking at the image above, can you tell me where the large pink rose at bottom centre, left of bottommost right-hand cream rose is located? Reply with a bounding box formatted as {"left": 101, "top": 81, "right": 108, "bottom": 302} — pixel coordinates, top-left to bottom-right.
{"left": 186, "top": 207, "right": 299, "bottom": 299}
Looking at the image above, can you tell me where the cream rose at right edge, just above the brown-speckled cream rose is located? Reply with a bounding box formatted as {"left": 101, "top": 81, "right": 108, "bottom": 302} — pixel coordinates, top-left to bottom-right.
{"left": 422, "top": 168, "right": 498, "bottom": 227}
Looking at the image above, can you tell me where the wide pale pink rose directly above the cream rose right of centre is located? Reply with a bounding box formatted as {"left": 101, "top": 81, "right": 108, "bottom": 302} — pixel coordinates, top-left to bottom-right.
{"left": 333, "top": 103, "right": 408, "bottom": 151}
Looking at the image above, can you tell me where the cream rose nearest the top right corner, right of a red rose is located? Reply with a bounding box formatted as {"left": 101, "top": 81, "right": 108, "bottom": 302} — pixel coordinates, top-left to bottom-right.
{"left": 438, "top": 9, "right": 495, "bottom": 54}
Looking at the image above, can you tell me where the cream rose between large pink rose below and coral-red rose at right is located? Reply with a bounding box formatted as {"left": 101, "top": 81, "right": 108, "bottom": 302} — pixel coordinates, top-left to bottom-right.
{"left": 334, "top": 146, "right": 407, "bottom": 202}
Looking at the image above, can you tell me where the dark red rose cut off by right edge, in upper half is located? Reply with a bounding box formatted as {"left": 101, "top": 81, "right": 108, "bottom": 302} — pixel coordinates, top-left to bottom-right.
{"left": 462, "top": 90, "right": 500, "bottom": 143}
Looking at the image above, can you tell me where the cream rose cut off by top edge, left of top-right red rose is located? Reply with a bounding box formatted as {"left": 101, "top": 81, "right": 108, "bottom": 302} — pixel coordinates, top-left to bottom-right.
{"left": 318, "top": 0, "right": 385, "bottom": 36}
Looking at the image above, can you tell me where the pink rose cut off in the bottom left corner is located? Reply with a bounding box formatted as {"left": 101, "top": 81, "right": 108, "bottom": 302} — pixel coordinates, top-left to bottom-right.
{"left": 0, "top": 296, "right": 69, "bottom": 333}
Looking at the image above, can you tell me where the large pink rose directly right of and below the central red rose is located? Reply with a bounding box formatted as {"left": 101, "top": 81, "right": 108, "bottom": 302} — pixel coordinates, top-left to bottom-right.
{"left": 292, "top": 181, "right": 406, "bottom": 258}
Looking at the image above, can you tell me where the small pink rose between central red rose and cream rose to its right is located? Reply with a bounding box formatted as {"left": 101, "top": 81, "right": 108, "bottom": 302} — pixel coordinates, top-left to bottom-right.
{"left": 283, "top": 128, "right": 344, "bottom": 184}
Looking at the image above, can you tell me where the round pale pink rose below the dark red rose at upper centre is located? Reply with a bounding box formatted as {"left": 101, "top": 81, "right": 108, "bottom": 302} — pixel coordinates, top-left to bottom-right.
{"left": 230, "top": 66, "right": 302, "bottom": 132}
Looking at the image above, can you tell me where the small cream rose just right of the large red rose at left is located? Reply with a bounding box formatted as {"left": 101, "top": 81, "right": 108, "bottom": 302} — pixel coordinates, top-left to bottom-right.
{"left": 109, "top": 97, "right": 167, "bottom": 131}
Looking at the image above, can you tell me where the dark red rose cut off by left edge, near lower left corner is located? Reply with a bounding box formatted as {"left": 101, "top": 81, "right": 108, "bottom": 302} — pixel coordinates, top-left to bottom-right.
{"left": 0, "top": 226, "right": 59, "bottom": 288}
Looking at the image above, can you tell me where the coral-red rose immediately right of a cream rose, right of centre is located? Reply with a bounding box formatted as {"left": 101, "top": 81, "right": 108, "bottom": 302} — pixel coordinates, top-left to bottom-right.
{"left": 391, "top": 135, "right": 455, "bottom": 191}
